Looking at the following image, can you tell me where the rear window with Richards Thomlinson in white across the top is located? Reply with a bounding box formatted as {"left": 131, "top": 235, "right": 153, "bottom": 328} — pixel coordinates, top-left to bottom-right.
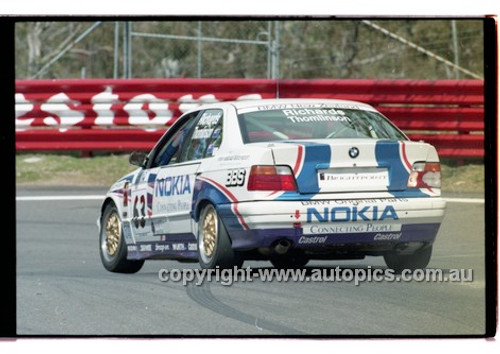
{"left": 238, "top": 107, "right": 407, "bottom": 143}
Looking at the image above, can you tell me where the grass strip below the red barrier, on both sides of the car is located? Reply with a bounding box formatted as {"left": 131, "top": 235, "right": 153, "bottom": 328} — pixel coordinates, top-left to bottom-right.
{"left": 16, "top": 154, "right": 484, "bottom": 192}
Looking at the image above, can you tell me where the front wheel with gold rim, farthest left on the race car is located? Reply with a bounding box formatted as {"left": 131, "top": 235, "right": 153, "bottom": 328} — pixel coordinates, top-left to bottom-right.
{"left": 99, "top": 204, "right": 144, "bottom": 273}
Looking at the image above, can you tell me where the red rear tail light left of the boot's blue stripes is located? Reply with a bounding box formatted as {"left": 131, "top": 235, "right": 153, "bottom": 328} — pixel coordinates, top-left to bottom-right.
{"left": 247, "top": 165, "right": 297, "bottom": 191}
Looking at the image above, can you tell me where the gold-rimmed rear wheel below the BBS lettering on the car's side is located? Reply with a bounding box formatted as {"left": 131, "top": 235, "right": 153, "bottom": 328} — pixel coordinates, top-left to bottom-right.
{"left": 198, "top": 204, "right": 243, "bottom": 269}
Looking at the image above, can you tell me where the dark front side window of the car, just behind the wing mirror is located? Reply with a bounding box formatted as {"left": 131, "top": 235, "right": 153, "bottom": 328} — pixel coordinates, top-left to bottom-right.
{"left": 152, "top": 112, "right": 199, "bottom": 167}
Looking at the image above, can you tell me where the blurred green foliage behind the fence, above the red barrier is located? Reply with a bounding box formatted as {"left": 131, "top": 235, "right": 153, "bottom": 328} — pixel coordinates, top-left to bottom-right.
{"left": 15, "top": 19, "right": 484, "bottom": 79}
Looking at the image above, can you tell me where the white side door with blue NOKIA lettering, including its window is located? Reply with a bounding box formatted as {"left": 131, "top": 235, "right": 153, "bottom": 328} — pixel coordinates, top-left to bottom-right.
{"left": 152, "top": 109, "right": 222, "bottom": 240}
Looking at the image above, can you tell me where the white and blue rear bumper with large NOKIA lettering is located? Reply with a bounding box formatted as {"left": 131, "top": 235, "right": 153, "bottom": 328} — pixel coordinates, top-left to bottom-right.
{"left": 219, "top": 197, "right": 446, "bottom": 251}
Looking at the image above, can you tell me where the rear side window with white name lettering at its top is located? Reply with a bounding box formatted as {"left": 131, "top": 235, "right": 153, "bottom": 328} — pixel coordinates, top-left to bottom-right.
{"left": 180, "top": 109, "right": 222, "bottom": 161}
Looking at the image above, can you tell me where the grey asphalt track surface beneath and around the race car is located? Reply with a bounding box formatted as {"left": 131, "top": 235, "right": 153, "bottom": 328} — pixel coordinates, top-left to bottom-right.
{"left": 16, "top": 187, "right": 485, "bottom": 336}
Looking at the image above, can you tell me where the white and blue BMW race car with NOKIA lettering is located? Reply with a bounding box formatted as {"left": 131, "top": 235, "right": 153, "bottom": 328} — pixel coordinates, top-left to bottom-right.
{"left": 98, "top": 99, "right": 446, "bottom": 273}
